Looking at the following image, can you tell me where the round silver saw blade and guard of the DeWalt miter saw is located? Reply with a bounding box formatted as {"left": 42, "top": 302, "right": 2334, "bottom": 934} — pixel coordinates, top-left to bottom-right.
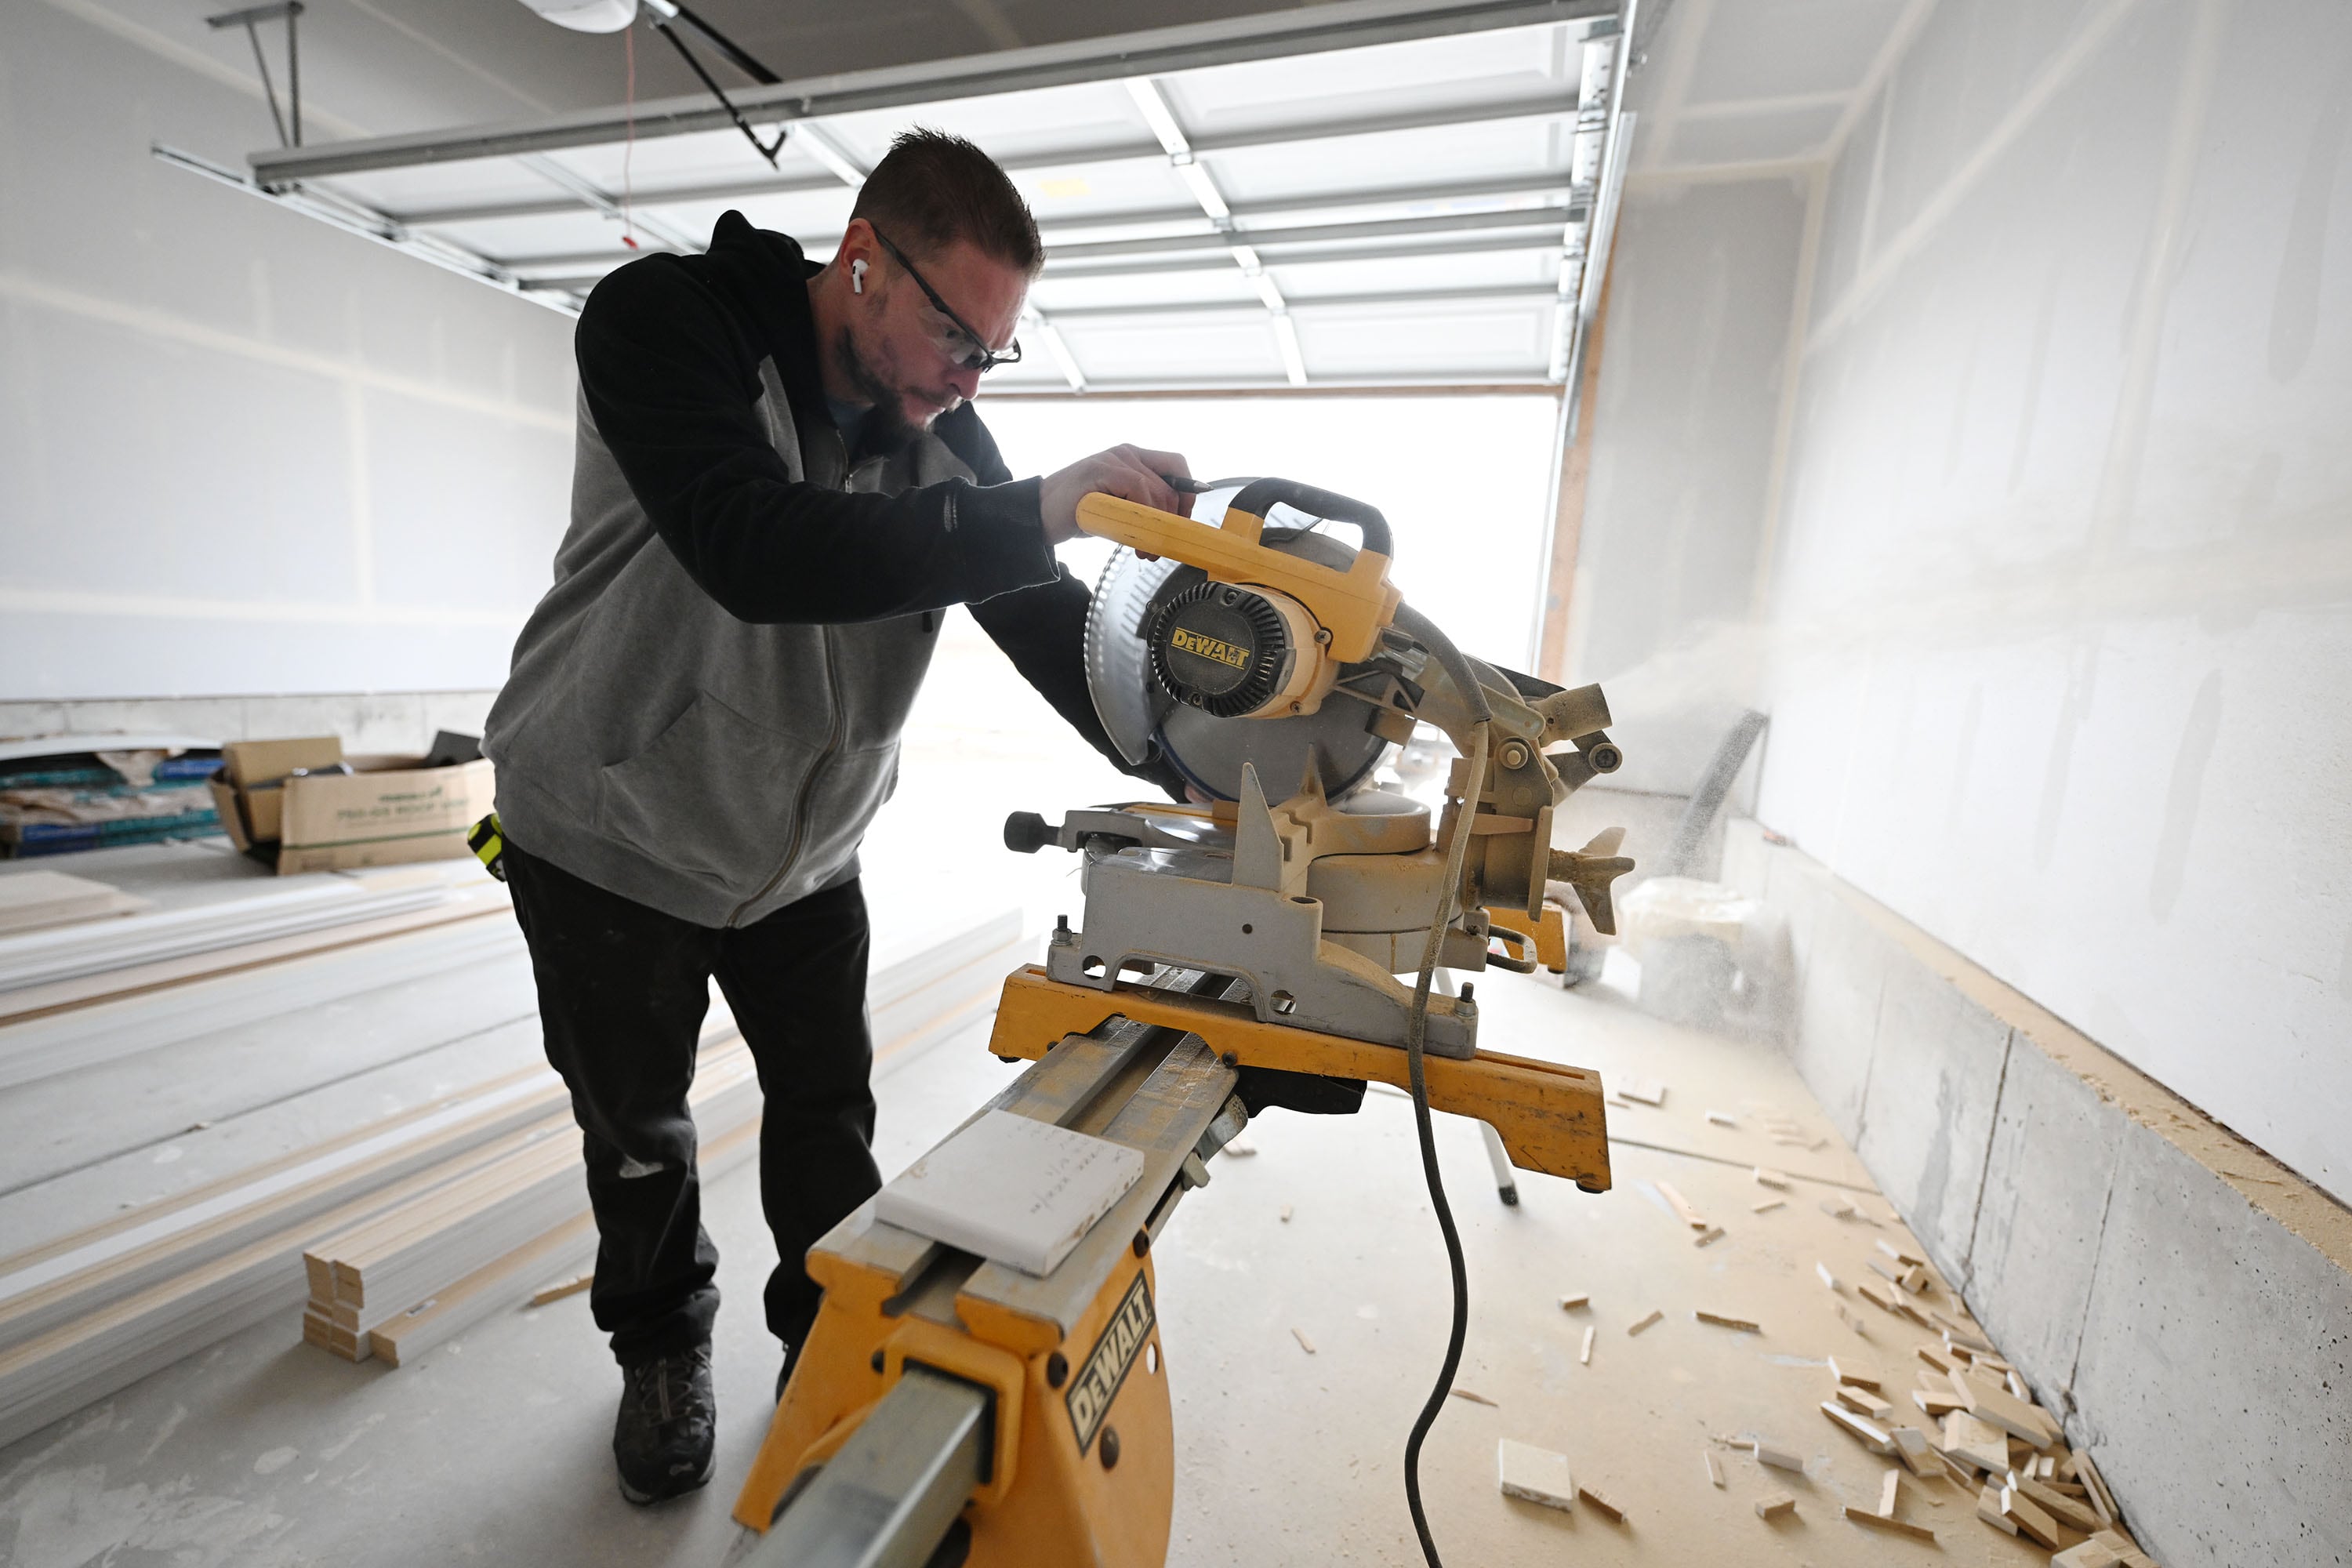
{"left": 1084, "top": 517, "right": 1388, "bottom": 799}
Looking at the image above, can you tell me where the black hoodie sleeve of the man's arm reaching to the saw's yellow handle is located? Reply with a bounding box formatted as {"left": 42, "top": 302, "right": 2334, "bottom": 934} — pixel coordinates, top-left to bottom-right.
{"left": 574, "top": 256, "right": 1056, "bottom": 626}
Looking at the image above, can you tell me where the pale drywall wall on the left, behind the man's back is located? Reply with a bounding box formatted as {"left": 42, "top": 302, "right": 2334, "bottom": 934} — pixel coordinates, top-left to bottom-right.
{"left": 0, "top": 0, "right": 572, "bottom": 701}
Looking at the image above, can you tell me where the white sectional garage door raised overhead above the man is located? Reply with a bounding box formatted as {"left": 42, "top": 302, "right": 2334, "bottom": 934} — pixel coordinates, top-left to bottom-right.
{"left": 160, "top": 0, "right": 1630, "bottom": 393}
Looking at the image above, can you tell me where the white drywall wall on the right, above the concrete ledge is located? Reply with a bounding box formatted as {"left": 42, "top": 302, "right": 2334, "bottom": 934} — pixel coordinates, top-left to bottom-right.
{"left": 1759, "top": 0, "right": 2352, "bottom": 1199}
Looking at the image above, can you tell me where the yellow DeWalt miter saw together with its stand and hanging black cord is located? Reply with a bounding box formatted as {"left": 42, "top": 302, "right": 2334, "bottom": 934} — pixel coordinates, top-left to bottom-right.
{"left": 736, "top": 480, "right": 1632, "bottom": 1568}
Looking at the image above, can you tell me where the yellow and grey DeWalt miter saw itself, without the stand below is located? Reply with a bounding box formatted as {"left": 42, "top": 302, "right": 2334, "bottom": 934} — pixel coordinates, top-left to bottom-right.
{"left": 1007, "top": 480, "right": 1632, "bottom": 1058}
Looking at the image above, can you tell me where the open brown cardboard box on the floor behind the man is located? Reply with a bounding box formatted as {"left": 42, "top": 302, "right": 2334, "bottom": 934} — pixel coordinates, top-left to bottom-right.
{"left": 212, "top": 736, "right": 494, "bottom": 877}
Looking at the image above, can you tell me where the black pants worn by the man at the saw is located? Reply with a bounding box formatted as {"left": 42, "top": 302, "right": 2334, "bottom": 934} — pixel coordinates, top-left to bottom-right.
{"left": 503, "top": 839, "right": 882, "bottom": 1363}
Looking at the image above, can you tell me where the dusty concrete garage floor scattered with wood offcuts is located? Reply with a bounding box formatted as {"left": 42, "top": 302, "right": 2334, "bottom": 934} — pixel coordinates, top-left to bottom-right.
{"left": 0, "top": 945, "right": 2070, "bottom": 1568}
